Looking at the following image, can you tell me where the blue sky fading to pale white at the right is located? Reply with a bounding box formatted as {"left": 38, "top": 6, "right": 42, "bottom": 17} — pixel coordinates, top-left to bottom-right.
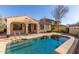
{"left": 0, "top": 5, "right": 79, "bottom": 24}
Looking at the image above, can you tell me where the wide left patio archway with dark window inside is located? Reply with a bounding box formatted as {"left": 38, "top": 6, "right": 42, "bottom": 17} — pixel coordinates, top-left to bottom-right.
{"left": 10, "top": 22, "right": 26, "bottom": 35}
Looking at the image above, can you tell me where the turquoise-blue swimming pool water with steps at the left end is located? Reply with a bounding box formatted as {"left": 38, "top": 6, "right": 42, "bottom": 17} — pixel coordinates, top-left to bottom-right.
{"left": 5, "top": 37, "right": 68, "bottom": 54}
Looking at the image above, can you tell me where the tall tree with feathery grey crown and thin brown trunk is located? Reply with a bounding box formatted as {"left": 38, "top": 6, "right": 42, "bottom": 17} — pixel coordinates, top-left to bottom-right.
{"left": 53, "top": 5, "right": 69, "bottom": 32}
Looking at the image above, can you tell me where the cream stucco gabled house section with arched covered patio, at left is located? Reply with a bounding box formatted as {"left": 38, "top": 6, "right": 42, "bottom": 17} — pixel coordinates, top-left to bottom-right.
{"left": 7, "top": 16, "right": 39, "bottom": 35}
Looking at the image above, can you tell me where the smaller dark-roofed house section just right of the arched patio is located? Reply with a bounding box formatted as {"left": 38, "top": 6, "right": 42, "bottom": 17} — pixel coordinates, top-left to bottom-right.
{"left": 39, "top": 18, "right": 53, "bottom": 32}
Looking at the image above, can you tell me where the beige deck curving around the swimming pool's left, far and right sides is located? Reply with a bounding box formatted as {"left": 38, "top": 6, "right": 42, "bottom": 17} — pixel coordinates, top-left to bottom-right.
{"left": 0, "top": 32, "right": 75, "bottom": 54}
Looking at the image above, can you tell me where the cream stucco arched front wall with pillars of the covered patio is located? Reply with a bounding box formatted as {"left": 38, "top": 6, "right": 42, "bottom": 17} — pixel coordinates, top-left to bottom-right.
{"left": 7, "top": 16, "right": 39, "bottom": 35}
